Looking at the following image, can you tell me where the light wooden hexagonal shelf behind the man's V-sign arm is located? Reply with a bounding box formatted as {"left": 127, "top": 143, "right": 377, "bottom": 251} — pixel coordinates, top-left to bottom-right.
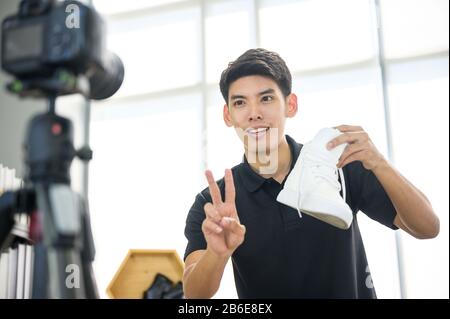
{"left": 106, "top": 249, "right": 184, "bottom": 299}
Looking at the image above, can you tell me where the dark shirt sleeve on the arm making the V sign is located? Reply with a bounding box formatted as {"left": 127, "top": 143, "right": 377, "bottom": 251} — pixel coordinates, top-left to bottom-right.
{"left": 184, "top": 191, "right": 211, "bottom": 260}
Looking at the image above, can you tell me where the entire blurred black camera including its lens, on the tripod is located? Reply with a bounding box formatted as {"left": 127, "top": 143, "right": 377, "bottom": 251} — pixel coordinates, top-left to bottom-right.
{"left": 1, "top": 0, "right": 124, "bottom": 100}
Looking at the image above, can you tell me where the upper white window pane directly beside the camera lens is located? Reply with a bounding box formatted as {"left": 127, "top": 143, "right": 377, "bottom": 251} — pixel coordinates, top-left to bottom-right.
{"left": 105, "top": 8, "right": 201, "bottom": 96}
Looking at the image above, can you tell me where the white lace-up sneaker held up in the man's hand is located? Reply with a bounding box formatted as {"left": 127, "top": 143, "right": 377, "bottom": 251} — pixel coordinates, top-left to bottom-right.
{"left": 277, "top": 128, "right": 353, "bottom": 229}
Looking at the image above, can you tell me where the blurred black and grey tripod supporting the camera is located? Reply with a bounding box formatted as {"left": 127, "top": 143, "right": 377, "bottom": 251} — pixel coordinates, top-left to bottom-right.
{"left": 0, "top": 70, "right": 98, "bottom": 299}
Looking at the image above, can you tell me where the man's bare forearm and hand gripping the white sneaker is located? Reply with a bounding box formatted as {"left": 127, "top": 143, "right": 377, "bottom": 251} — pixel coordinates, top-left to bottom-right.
{"left": 328, "top": 125, "right": 440, "bottom": 239}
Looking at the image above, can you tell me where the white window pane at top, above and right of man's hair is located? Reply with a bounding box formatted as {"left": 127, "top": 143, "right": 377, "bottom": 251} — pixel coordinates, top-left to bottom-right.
{"left": 260, "top": 0, "right": 374, "bottom": 72}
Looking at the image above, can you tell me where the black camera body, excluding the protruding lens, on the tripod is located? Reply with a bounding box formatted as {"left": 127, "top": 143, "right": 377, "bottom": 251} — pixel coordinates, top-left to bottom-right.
{"left": 2, "top": 1, "right": 105, "bottom": 76}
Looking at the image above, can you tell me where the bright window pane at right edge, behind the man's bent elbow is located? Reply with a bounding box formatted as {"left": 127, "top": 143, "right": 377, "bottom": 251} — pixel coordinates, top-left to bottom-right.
{"left": 389, "top": 76, "right": 449, "bottom": 298}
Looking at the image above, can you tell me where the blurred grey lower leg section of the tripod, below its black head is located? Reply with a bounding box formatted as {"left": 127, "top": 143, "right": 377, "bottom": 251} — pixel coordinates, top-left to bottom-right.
{"left": 33, "top": 184, "right": 86, "bottom": 299}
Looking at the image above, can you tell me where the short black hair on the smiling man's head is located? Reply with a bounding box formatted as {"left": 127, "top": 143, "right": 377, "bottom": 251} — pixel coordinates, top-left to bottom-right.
{"left": 220, "top": 48, "right": 292, "bottom": 104}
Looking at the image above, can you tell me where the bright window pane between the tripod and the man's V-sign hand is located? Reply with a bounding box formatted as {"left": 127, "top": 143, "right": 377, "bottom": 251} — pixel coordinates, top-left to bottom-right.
{"left": 89, "top": 93, "right": 203, "bottom": 296}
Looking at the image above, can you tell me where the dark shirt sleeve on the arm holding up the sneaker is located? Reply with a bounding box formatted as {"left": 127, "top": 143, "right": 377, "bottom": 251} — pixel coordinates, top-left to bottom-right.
{"left": 344, "top": 161, "right": 398, "bottom": 229}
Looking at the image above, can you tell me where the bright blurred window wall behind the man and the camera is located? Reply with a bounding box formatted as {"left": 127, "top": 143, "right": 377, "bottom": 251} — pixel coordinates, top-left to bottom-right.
{"left": 0, "top": 0, "right": 449, "bottom": 298}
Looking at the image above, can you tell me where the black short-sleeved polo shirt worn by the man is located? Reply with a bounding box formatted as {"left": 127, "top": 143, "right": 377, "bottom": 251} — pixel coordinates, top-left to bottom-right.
{"left": 184, "top": 136, "right": 397, "bottom": 298}
